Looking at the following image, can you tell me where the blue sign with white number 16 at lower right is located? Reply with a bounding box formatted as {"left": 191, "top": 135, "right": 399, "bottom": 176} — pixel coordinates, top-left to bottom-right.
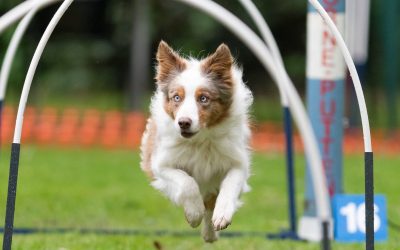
{"left": 332, "top": 194, "right": 388, "bottom": 242}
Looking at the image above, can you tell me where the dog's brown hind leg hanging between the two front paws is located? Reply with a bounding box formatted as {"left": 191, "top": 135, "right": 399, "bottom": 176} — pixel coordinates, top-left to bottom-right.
{"left": 201, "top": 194, "right": 218, "bottom": 243}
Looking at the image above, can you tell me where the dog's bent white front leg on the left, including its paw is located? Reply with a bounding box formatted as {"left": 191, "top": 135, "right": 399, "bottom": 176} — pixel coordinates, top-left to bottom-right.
{"left": 152, "top": 168, "right": 205, "bottom": 227}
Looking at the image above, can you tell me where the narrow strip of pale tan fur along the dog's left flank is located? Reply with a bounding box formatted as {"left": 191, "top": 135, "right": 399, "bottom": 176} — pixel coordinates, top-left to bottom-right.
{"left": 140, "top": 118, "right": 157, "bottom": 179}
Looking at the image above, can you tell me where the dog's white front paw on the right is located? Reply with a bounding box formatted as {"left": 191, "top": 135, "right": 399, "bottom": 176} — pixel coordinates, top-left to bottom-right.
{"left": 212, "top": 202, "right": 235, "bottom": 231}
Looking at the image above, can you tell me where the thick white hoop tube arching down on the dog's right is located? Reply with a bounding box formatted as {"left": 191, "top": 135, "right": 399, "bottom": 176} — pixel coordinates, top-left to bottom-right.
{"left": 178, "top": 0, "right": 331, "bottom": 225}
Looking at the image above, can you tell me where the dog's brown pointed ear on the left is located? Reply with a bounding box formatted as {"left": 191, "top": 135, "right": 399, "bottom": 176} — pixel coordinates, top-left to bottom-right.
{"left": 155, "top": 41, "right": 186, "bottom": 84}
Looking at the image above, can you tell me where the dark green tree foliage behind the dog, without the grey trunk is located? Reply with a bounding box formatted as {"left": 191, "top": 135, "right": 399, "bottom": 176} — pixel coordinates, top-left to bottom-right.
{"left": 0, "top": 0, "right": 390, "bottom": 112}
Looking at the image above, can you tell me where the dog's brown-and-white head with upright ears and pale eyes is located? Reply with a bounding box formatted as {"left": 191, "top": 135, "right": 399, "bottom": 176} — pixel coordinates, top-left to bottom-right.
{"left": 155, "top": 41, "right": 234, "bottom": 138}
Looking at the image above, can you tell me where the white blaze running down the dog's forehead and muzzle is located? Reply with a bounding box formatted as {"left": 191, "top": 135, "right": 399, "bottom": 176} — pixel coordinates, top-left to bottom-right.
{"left": 174, "top": 62, "right": 206, "bottom": 133}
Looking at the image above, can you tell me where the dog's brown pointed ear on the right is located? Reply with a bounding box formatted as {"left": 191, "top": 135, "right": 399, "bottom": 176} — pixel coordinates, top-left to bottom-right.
{"left": 202, "top": 43, "right": 233, "bottom": 85}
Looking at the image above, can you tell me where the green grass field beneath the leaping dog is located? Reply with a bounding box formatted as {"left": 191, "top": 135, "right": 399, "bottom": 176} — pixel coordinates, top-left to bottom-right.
{"left": 0, "top": 146, "right": 400, "bottom": 250}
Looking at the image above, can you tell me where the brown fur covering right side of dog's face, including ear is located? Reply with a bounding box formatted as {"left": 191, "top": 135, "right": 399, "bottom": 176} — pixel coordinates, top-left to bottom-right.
{"left": 196, "top": 44, "right": 233, "bottom": 127}
